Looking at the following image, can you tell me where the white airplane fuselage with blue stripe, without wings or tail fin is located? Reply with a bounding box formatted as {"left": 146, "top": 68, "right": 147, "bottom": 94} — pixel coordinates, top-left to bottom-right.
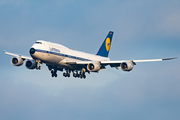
{"left": 31, "top": 40, "right": 110, "bottom": 67}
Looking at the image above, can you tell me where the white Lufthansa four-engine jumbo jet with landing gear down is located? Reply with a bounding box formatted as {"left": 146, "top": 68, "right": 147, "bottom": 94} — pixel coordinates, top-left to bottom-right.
{"left": 4, "top": 31, "right": 175, "bottom": 78}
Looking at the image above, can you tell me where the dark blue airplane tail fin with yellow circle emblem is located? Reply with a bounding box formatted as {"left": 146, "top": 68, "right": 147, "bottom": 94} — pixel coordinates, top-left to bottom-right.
{"left": 96, "top": 31, "right": 114, "bottom": 57}
